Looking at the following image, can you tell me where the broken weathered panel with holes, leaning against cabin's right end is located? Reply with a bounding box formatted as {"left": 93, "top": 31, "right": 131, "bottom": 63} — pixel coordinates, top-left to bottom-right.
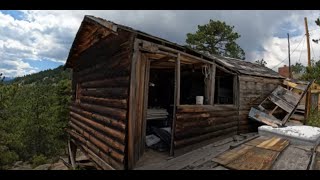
{"left": 249, "top": 79, "right": 313, "bottom": 127}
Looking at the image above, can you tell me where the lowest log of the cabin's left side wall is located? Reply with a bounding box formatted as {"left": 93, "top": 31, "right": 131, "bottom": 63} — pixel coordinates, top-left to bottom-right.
{"left": 69, "top": 122, "right": 124, "bottom": 164}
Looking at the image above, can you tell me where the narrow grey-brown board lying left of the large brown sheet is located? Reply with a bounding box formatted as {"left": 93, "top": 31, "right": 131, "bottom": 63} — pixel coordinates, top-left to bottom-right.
{"left": 212, "top": 145, "right": 253, "bottom": 165}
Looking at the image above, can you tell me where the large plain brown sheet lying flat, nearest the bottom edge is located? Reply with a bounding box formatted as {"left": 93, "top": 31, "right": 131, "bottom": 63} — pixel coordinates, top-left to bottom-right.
{"left": 227, "top": 147, "right": 280, "bottom": 170}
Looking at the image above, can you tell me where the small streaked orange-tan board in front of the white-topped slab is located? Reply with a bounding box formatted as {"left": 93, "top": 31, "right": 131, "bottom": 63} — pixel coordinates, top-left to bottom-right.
{"left": 257, "top": 137, "right": 289, "bottom": 152}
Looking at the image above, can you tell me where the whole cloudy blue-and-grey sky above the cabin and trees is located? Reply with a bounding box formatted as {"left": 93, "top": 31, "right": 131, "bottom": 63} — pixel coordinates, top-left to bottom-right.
{"left": 0, "top": 10, "right": 320, "bottom": 76}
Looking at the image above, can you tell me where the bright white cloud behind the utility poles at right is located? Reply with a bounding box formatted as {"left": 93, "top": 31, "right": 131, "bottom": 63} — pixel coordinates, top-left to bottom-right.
{"left": 249, "top": 11, "right": 320, "bottom": 71}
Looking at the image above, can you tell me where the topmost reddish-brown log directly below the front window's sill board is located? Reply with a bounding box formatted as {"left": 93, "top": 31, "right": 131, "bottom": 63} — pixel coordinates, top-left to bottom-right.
{"left": 176, "top": 111, "right": 238, "bottom": 121}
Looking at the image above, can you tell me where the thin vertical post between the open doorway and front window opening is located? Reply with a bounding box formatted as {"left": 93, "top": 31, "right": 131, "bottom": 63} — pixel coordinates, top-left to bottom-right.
{"left": 170, "top": 53, "right": 181, "bottom": 156}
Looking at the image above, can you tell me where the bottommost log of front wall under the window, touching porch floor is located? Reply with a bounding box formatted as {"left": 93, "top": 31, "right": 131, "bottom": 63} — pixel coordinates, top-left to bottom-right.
{"left": 174, "top": 127, "right": 237, "bottom": 148}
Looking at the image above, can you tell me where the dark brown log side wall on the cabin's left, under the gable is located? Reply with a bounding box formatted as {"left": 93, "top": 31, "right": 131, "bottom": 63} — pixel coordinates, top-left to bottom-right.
{"left": 69, "top": 31, "right": 133, "bottom": 169}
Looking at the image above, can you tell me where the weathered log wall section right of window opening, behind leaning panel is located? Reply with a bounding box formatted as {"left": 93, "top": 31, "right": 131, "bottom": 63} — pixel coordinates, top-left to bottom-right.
{"left": 238, "top": 75, "right": 283, "bottom": 133}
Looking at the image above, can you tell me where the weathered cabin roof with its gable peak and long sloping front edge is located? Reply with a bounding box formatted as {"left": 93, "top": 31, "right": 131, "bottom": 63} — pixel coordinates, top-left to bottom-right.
{"left": 65, "top": 15, "right": 283, "bottom": 78}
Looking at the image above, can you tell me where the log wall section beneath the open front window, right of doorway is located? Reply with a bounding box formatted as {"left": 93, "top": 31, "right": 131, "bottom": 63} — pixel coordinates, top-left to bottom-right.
{"left": 174, "top": 105, "right": 238, "bottom": 148}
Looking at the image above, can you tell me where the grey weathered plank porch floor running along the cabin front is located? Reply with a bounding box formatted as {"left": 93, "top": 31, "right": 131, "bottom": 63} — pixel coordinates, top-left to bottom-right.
{"left": 134, "top": 133, "right": 257, "bottom": 170}
